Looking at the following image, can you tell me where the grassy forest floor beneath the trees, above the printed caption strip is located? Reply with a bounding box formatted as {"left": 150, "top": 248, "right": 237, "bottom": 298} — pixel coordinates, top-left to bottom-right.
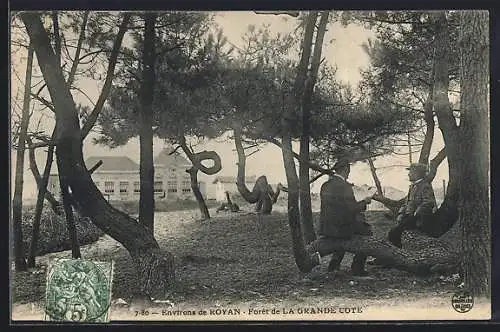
{"left": 12, "top": 201, "right": 476, "bottom": 320}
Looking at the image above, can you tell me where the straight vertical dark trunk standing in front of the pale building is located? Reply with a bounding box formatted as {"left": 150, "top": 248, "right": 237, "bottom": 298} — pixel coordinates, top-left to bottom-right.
{"left": 139, "top": 13, "right": 156, "bottom": 234}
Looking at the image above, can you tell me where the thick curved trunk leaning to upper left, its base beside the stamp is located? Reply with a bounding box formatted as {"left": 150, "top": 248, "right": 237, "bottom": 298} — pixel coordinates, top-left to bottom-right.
{"left": 20, "top": 12, "right": 174, "bottom": 298}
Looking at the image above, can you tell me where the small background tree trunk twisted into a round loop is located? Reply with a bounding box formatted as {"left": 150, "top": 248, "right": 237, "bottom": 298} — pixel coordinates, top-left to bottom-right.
{"left": 179, "top": 136, "right": 222, "bottom": 220}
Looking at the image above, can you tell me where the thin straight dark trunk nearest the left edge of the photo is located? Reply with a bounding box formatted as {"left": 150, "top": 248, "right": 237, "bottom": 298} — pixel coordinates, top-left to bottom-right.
{"left": 12, "top": 42, "right": 34, "bottom": 271}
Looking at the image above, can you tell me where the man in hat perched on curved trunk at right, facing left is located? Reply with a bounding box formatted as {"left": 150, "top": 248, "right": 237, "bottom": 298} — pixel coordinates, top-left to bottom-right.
{"left": 389, "top": 163, "right": 436, "bottom": 248}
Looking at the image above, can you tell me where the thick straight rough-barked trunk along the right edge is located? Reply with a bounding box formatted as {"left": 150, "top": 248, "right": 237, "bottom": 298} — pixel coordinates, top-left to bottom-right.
{"left": 458, "top": 10, "right": 491, "bottom": 297}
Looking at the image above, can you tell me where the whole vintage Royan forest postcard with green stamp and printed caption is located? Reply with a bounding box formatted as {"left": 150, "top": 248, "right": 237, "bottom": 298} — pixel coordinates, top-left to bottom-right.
{"left": 9, "top": 10, "right": 491, "bottom": 324}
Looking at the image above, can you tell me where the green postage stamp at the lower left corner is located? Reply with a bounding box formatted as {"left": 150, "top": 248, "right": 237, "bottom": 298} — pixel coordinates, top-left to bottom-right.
{"left": 45, "top": 259, "right": 113, "bottom": 323}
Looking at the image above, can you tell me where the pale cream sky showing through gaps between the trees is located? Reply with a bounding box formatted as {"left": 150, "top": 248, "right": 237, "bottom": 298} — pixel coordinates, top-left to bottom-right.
{"left": 11, "top": 12, "right": 448, "bottom": 199}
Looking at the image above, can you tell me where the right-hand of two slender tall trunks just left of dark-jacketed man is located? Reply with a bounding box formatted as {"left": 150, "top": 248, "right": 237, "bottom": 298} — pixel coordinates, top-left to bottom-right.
{"left": 299, "top": 11, "right": 329, "bottom": 243}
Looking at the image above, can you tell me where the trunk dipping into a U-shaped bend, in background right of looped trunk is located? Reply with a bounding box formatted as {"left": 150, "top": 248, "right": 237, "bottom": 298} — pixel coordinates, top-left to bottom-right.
{"left": 234, "top": 129, "right": 279, "bottom": 214}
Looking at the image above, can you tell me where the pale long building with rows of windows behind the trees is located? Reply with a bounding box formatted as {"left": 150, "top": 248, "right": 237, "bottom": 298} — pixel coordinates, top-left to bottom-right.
{"left": 48, "top": 149, "right": 206, "bottom": 201}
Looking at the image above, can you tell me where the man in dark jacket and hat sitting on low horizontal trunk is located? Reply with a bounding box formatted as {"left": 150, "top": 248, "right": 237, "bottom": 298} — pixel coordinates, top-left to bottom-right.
{"left": 309, "top": 160, "right": 372, "bottom": 276}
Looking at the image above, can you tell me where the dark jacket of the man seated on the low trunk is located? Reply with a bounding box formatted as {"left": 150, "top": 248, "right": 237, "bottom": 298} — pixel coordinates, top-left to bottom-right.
{"left": 319, "top": 176, "right": 369, "bottom": 238}
